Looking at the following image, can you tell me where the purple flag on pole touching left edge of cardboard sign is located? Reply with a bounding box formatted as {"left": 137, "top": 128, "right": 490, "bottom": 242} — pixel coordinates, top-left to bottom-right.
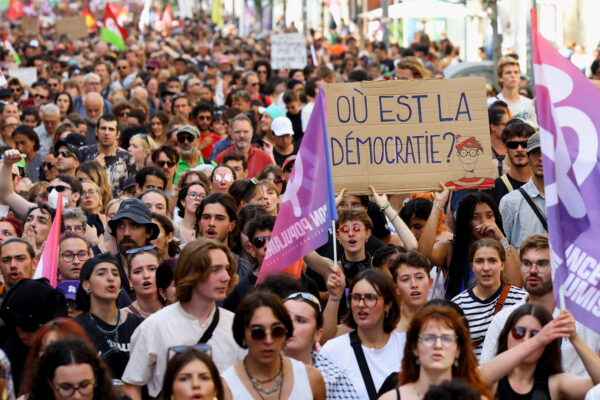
{"left": 257, "top": 87, "right": 337, "bottom": 284}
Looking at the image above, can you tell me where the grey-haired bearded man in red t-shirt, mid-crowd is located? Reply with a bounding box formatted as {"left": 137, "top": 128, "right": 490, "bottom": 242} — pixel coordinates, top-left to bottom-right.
{"left": 215, "top": 114, "right": 273, "bottom": 178}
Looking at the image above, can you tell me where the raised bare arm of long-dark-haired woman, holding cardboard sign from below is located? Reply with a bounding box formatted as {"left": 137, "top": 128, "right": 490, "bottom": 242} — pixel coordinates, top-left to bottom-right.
{"left": 418, "top": 182, "right": 450, "bottom": 271}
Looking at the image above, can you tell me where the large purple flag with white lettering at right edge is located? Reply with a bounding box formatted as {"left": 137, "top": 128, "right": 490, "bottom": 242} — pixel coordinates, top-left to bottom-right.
{"left": 532, "top": 10, "right": 600, "bottom": 332}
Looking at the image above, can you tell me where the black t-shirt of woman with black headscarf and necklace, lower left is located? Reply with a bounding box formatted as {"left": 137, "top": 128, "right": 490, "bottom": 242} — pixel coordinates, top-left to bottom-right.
{"left": 73, "top": 312, "right": 144, "bottom": 379}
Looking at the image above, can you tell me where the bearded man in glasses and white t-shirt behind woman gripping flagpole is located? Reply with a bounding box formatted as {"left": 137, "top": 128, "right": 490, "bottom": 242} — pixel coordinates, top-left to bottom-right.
{"left": 479, "top": 234, "right": 600, "bottom": 376}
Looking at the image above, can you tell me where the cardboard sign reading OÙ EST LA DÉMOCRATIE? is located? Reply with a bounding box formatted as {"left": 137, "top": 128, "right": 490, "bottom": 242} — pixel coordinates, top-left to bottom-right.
{"left": 323, "top": 77, "right": 494, "bottom": 194}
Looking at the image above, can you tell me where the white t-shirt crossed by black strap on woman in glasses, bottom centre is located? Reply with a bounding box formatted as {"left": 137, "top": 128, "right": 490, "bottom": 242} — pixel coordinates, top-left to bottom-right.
{"left": 320, "top": 332, "right": 406, "bottom": 399}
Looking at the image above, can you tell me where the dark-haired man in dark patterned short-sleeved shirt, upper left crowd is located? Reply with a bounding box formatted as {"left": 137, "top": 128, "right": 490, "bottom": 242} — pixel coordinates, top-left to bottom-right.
{"left": 81, "top": 114, "right": 137, "bottom": 197}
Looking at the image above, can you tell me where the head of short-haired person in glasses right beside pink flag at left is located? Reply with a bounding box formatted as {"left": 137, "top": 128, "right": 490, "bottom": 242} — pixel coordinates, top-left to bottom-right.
{"left": 58, "top": 231, "right": 91, "bottom": 281}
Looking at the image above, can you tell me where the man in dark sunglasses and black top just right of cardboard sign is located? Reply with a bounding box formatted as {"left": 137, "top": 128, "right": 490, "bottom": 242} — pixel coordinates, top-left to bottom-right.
{"left": 490, "top": 119, "right": 535, "bottom": 204}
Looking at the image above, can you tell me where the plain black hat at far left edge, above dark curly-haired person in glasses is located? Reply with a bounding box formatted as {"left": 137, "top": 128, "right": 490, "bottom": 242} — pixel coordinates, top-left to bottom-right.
{"left": 0, "top": 279, "right": 68, "bottom": 332}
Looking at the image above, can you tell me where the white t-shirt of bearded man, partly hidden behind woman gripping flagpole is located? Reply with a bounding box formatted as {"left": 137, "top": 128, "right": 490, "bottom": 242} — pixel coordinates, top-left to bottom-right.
{"left": 479, "top": 298, "right": 600, "bottom": 376}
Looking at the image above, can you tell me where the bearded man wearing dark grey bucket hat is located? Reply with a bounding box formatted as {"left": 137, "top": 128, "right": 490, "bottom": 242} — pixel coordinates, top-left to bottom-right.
{"left": 108, "top": 199, "right": 159, "bottom": 296}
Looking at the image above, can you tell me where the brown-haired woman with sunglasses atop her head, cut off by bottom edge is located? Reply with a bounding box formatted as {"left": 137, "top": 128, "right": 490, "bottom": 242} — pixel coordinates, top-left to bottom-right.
{"left": 161, "top": 345, "right": 224, "bottom": 400}
